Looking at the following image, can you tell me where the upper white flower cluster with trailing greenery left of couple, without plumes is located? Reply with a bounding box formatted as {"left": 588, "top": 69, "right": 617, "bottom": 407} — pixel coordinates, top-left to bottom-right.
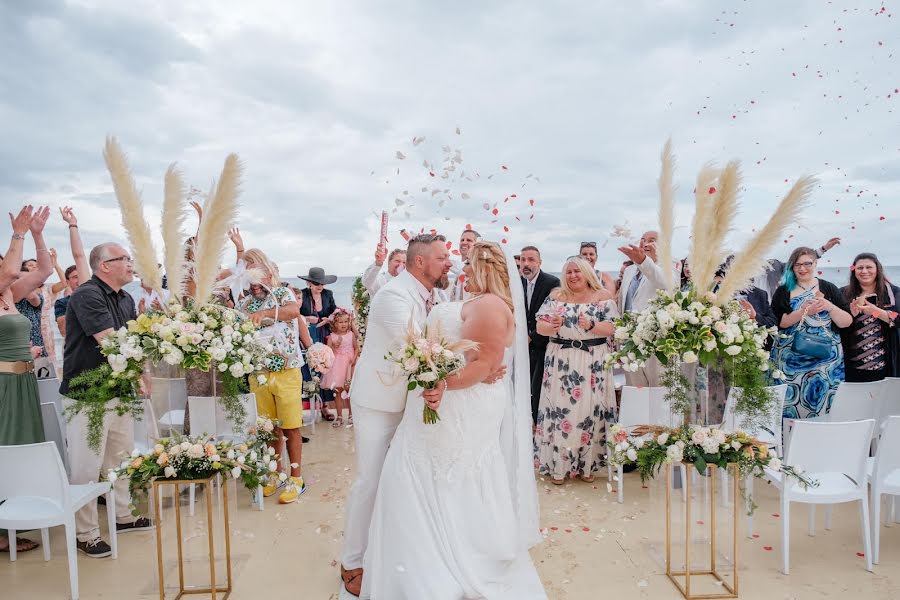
{"left": 66, "top": 300, "right": 272, "bottom": 449}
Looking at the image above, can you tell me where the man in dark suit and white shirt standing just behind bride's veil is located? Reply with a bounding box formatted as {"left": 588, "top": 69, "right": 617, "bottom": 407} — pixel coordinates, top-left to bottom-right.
{"left": 519, "top": 246, "right": 559, "bottom": 421}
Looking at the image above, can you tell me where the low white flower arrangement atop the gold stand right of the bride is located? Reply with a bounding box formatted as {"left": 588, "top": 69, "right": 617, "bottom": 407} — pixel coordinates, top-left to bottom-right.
{"left": 606, "top": 425, "right": 819, "bottom": 511}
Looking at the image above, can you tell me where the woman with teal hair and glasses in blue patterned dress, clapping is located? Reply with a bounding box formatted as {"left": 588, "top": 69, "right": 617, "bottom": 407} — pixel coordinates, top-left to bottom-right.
{"left": 772, "top": 246, "right": 853, "bottom": 419}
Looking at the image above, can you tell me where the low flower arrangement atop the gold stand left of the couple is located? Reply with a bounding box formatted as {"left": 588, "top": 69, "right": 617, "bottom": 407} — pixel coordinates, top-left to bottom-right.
{"left": 106, "top": 417, "right": 287, "bottom": 514}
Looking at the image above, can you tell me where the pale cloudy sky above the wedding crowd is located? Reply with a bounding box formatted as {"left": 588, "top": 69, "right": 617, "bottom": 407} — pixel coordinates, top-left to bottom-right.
{"left": 0, "top": 0, "right": 900, "bottom": 275}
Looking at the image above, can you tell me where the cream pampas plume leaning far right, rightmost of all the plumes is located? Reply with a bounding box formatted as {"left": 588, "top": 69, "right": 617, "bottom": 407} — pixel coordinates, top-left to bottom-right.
{"left": 717, "top": 176, "right": 817, "bottom": 304}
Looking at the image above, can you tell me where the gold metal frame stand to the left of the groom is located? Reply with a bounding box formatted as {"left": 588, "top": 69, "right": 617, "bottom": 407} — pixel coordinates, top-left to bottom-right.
{"left": 153, "top": 475, "right": 232, "bottom": 600}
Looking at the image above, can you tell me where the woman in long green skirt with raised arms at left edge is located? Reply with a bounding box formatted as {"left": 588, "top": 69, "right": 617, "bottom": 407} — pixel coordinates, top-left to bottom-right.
{"left": 0, "top": 206, "right": 52, "bottom": 552}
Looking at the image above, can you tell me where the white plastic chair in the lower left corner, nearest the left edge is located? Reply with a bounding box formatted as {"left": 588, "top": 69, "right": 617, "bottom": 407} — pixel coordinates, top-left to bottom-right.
{"left": 0, "top": 442, "right": 118, "bottom": 600}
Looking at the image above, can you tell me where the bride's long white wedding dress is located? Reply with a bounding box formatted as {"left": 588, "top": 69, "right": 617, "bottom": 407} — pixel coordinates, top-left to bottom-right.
{"left": 362, "top": 302, "right": 547, "bottom": 600}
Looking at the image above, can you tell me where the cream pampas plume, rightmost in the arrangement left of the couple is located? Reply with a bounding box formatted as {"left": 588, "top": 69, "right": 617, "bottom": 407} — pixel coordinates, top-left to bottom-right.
{"left": 194, "top": 154, "right": 243, "bottom": 304}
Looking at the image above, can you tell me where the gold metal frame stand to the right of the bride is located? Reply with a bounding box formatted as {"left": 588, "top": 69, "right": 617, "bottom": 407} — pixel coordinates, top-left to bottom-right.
{"left": 666, "top": 464, "right": 740, "bottom": 600}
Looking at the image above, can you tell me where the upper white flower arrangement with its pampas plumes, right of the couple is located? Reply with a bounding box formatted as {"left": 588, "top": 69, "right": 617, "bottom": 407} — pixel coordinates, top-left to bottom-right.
{"left": 607, "top": 142, "right": 815, "bottom": 427}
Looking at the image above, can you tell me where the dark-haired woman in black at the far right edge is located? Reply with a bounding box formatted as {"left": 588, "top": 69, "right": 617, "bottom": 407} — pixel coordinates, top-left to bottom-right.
{"left": 841, "top": 252, "right": 900, "bottom": 381}
